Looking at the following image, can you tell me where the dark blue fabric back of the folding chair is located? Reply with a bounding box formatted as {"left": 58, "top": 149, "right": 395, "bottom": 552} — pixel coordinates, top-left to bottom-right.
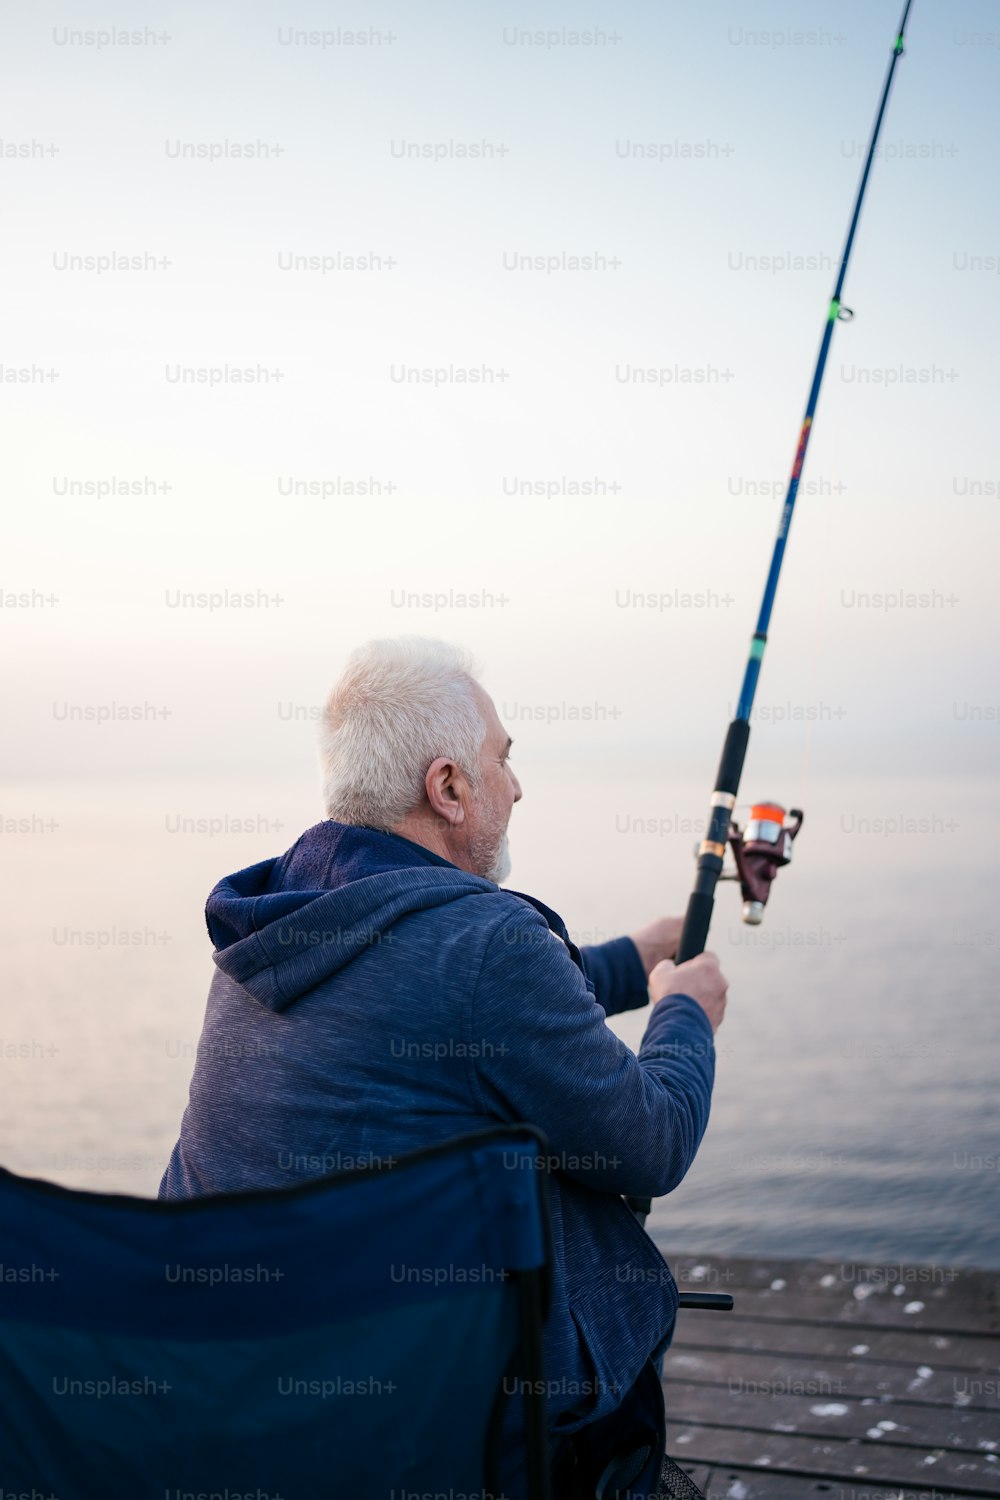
{"left": 0, "top": 1127, "right": 550, "bottom": 1500}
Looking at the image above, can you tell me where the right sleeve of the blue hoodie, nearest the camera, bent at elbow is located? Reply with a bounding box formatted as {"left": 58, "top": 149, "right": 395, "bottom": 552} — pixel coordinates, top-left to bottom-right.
{"left": 471, "top": 894, "right": 715, "bottom": 1197}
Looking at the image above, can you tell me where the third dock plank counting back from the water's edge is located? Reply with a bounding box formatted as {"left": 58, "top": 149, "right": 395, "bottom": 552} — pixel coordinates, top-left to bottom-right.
{"left": 664, "top": 1344, "right": 1000, "bottom": 1427}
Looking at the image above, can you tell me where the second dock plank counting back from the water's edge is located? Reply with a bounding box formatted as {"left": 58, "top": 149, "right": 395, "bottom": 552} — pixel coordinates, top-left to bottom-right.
{"left": 672, "top": 1311, "right": 1000, "bottom": 1374}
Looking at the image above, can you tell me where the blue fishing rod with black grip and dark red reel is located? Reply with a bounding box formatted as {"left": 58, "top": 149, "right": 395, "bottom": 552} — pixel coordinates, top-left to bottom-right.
{"left": 628, "top": 0, "right": 913, "bottom": 1220}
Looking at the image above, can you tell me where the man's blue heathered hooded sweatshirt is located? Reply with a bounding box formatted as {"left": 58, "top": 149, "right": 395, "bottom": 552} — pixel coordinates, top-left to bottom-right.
{"left": 160, "top": 822, "right": 714, "bottom": 1433}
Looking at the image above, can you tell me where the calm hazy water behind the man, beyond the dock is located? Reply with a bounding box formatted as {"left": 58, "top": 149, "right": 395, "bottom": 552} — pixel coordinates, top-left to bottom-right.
{"left": 0, "top": 762, "right": 1000, "bottom": 1266}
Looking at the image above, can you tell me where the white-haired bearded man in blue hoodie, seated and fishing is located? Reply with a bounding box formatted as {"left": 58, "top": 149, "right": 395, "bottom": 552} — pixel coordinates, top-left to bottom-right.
{"left": 160, "top": 639, "right": 727, "bottom": 1493}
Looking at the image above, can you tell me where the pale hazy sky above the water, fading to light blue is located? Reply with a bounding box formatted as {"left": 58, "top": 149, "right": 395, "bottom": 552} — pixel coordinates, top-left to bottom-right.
{"left": 0, "top": 0, "right": 1000, "bottom": 791}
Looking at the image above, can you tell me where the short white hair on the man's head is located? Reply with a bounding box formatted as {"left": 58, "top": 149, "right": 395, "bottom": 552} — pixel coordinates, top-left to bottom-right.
{"left": 319, "top": 636, "right": 486, "bottom": 828}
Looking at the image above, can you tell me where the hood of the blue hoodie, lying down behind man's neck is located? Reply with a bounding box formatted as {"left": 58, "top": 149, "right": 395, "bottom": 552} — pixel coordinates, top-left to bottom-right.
{"left": 205, "top": 821, "right": 499, "bottom": 1011}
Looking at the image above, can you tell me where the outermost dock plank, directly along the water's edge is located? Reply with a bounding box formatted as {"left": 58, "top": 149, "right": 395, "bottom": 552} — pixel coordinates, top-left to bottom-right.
{"left": 660, "top": 1247, "right": 1000, "bottom": 1334}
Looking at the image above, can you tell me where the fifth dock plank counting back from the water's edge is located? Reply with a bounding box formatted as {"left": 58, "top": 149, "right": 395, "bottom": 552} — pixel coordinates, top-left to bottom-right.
{"left": 667, "top": 1422, "right": 1000, "bottom": 1497}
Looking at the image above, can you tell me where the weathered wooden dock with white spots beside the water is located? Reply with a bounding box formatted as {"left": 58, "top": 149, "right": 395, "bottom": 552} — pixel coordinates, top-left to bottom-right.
{"left": 664, "top": 1253, "right": 1000, "bottom": 1500}
